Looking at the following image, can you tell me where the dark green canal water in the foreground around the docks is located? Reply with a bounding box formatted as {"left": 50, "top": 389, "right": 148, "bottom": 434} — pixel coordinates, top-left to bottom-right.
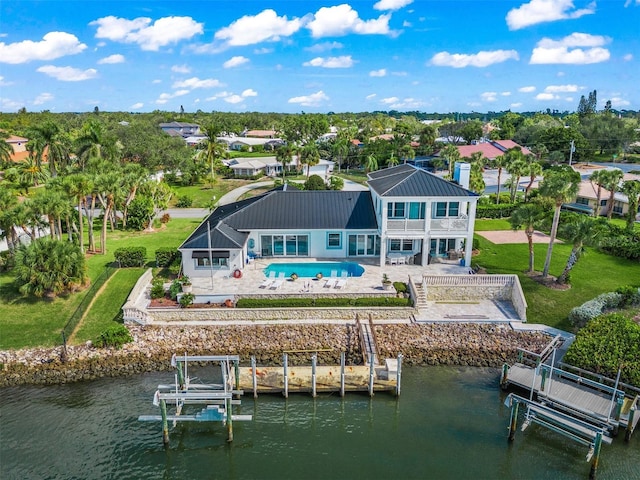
{"left": 0, "top": 367, "right": 640, "bottom": 480}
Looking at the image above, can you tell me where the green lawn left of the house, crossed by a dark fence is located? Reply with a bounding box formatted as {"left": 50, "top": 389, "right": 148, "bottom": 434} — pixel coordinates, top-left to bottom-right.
{"left": 0, "top": 218, "right": 200, "bottom": 349}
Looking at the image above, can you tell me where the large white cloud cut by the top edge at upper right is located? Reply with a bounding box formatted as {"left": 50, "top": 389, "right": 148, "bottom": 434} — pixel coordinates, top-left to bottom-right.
{"left": 506, "top": 0, "right": 596, "bottom": 30}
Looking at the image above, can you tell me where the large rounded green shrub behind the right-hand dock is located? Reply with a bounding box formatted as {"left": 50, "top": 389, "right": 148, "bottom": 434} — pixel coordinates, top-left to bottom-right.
{"left": 564, "top": 313, "right": 640, "bottom": 387}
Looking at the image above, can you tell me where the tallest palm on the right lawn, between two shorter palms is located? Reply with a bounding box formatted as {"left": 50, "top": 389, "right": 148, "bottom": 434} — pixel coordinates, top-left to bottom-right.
{"left": 540, "top": 165, "right": 581, "bottom": 278}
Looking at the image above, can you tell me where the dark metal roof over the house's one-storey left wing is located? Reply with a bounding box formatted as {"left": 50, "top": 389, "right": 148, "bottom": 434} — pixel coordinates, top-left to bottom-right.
{"left": 179, "top": 189, "right": 378, "bottom": 249}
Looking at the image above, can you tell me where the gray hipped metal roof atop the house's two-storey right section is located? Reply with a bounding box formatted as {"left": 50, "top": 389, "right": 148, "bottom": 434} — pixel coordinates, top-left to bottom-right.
{"left": 368, "top": 165, "right": 478, "bottom": 197}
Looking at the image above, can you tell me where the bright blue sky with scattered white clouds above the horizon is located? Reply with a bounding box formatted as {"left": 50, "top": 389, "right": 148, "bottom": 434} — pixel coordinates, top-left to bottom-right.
{"left": 0, "top": 0, "right": 640, "bottom": 113}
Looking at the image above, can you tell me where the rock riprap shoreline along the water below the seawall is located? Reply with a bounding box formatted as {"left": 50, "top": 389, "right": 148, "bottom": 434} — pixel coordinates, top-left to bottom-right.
{"left": 0, "top": 324, "right": 549, "bottom": 386}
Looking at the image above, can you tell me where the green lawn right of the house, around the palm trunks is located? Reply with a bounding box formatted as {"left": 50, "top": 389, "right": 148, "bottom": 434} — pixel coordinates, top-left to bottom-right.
{"left": 473, "top": 235, "right": 640, "bottom": 331}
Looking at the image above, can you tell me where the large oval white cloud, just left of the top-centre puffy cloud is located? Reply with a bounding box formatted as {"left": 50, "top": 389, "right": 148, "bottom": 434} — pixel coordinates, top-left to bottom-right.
{"left": 214, "top": 9, "right": 303, "bottom": 47}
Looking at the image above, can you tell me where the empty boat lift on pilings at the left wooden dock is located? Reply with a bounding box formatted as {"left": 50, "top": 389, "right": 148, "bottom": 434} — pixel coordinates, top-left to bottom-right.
{"left": 138, "top": 354, "right": 252, "bottom": 445}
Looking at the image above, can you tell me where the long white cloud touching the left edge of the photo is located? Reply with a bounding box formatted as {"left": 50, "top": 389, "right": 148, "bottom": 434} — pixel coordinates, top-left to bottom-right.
{"left": 0, "top": 32, "right": 87, "bottom": 64}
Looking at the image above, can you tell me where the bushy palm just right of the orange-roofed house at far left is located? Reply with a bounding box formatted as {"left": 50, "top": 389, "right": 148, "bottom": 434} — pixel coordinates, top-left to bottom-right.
{"left": 27, "top": 120, "right": 70, "bottom": 177}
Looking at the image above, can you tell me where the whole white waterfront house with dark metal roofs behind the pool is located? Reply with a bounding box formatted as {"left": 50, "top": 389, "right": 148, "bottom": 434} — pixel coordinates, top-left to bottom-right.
{"left": 179, "top": 165, "right": 478, "bottom": 277}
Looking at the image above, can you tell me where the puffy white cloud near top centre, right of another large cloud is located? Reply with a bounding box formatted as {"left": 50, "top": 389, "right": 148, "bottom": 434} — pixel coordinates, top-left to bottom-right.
{"left": 307, "top": 3, "right": 391, "bottom": 38}
